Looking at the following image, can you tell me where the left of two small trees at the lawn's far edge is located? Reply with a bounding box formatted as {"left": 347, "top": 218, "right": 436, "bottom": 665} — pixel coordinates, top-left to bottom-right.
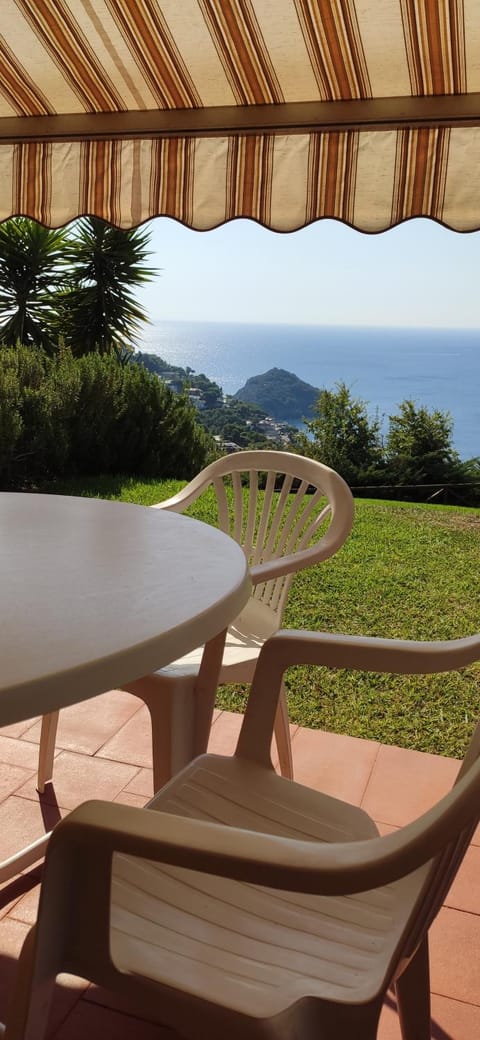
{"left": 299, "top": 383, "right": 382, "bottom": 486}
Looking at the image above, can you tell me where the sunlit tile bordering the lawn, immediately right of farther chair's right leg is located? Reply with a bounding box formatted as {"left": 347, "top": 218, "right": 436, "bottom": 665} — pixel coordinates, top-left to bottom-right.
{"left": 293, "top": 727, "right": 378, "bottom": 804}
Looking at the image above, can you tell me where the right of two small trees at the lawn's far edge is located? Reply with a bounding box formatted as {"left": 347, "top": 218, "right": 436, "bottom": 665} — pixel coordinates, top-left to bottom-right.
{"left": 386, "top": 400, "right": 463, "bottom": 484}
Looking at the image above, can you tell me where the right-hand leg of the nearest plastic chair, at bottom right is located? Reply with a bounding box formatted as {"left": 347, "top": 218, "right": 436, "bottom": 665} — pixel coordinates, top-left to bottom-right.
{"left": 395, "top": 936, "right": 430, "bottom": 1040}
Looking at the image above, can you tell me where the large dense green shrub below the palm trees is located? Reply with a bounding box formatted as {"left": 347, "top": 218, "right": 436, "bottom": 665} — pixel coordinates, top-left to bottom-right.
{"left": 0, "top": 345, "right": 210, "bottom": 490}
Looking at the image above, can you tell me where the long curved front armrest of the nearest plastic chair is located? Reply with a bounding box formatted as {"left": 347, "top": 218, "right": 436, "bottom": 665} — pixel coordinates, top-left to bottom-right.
{"left": 47, "top": 760, "right": 480, "bottom": 895}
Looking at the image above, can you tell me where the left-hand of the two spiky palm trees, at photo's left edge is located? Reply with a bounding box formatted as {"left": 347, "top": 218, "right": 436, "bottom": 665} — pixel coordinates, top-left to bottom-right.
{"left": 0, "top": 216, "right": 68, "bottom": 353}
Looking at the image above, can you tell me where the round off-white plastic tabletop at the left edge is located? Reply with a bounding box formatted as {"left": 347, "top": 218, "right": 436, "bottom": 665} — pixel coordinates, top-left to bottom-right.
{"left": 0, "top": 493, "right": 250, "bottom": 726}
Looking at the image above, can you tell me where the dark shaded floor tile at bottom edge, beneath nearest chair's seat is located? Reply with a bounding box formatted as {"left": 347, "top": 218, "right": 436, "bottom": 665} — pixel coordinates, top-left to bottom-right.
{"left": 49, "top": 999, "right": 179, "bottom": 1040}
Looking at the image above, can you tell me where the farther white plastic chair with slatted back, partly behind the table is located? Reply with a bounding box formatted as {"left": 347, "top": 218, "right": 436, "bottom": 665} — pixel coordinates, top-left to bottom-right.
{"left": 38, "top": 451, "right": 353, "bottom": 791}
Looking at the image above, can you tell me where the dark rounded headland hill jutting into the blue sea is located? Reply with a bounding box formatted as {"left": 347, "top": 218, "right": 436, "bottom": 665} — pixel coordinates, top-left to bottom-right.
{"left": 234, "top": 368, "right": 320, "bottom": 422}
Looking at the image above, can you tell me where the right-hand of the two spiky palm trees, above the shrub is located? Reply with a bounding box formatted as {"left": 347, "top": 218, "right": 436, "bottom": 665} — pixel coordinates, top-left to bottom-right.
{"left": 58, "top": 216, "right": 155, "bottom": 358}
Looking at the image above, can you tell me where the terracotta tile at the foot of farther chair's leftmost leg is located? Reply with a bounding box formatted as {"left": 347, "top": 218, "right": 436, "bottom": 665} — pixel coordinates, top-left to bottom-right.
{"left": 18, "top": 751, "right": 136, "bottom": 809}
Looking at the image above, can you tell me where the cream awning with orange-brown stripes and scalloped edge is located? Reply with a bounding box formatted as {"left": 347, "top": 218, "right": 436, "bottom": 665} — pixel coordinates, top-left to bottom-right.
{"left": 0, "top": 0, "right": 480, "bottom": 232}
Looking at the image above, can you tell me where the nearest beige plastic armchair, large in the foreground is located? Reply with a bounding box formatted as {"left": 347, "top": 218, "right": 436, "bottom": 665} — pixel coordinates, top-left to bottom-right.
{"left": 6, "top": 632, "right": 480, "bottom": 1040}
